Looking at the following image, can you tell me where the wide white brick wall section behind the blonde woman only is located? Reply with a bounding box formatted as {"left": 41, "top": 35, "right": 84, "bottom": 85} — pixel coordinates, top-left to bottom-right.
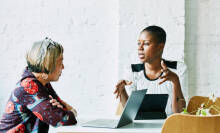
{"left": 0, "top": 0, "right": 118, "bottom": 115}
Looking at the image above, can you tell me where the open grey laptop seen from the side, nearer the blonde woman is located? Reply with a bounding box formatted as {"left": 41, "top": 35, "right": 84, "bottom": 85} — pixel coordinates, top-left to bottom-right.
{"left": 81, "top": 89, "right": 147, "bottom": 128}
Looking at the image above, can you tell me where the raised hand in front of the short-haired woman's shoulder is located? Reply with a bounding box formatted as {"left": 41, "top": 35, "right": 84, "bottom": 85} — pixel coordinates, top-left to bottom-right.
{"left": 159, "top": 61, "right": 179, "bottom": 84}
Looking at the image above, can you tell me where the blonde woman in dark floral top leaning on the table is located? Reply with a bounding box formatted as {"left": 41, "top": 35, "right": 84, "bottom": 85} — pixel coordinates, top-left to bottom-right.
{"left": 0, "top": 38, "right": 77, "bottom": 133}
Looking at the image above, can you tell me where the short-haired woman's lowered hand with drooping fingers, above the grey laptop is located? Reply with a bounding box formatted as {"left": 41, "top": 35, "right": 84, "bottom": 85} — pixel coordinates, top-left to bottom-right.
{"left": 114, "top": 80, "right": 132, "bottom": 98}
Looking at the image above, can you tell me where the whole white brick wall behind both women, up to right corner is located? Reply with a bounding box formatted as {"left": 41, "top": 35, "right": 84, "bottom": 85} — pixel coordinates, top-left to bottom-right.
{"left": 0, "top": 0, "right": 185, "bottom": 121}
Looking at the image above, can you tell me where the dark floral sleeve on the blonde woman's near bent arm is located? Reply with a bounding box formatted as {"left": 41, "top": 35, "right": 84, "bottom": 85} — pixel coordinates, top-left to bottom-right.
{"left": 17, "top": 79, "right": 77, "bottom": 127}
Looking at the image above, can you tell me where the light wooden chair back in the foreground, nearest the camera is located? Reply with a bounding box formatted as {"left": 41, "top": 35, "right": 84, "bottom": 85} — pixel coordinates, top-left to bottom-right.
{"left": 161, "top": 113, "right": 220, "bottom": 133}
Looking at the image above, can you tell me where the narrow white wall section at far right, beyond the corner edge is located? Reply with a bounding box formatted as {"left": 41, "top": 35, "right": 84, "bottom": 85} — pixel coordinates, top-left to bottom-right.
{"left": 185, "top": 0, "right": 220, "bottom": 96}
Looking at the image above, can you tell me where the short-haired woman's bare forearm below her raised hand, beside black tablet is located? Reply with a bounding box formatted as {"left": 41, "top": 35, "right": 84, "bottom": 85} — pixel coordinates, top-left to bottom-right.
{"left": 172, "top": 78, "right": 186, "bottom": 113}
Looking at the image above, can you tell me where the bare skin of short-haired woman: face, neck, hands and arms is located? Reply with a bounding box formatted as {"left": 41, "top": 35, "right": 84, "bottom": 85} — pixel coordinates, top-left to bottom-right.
{"left": 114, "top": 31, "right": 186, "bottom": 113}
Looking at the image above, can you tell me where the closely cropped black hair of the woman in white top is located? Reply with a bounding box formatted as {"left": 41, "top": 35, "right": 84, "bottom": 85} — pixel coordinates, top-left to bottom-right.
{"left": 142, "top": 25, "right": 166, "bottom": 44}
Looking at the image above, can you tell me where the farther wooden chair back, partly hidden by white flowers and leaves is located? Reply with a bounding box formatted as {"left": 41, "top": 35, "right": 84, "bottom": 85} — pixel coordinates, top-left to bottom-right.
{"left": 187, "top": 96, "right": 220, "bottom": 115}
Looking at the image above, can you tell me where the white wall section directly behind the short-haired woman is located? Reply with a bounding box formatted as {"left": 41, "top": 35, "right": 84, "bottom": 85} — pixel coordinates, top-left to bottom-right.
{"left": 118, "top": 0, "right": 188, "bottom": 98}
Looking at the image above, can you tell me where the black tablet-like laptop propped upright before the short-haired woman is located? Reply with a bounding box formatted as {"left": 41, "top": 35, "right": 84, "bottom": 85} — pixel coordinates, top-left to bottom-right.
{"left": 135, "top": 94, "right": 169, "bottom": 120}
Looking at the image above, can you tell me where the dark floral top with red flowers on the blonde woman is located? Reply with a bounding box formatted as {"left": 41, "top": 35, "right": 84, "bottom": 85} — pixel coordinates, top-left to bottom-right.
{"left": 0, "top": 68, "right": 77, "bottom": 133}
